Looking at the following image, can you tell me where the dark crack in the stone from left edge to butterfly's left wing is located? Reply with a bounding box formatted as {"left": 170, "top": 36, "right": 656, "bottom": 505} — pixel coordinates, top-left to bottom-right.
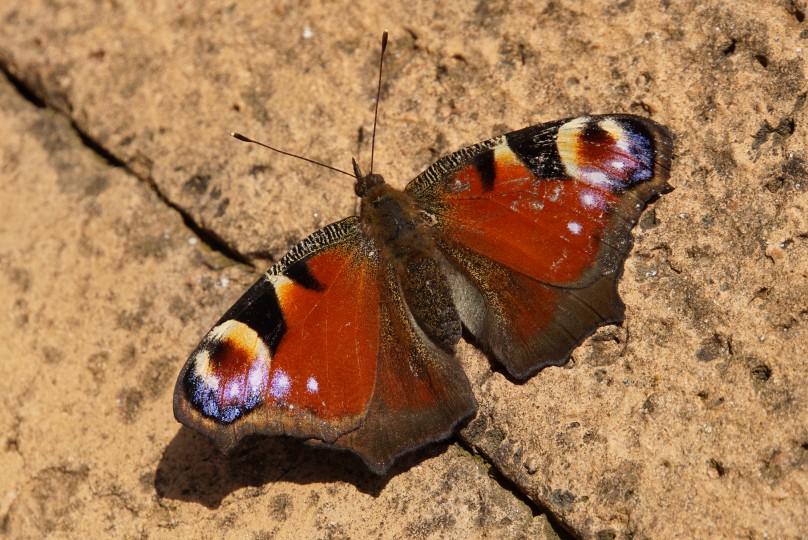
{"left": 0, "top": 61, "right": 254, "bottom": 268}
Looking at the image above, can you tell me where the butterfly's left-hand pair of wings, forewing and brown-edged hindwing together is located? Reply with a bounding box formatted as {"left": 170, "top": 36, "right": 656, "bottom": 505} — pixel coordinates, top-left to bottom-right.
{"left": 174, "top": 217, "right": 476, "bottom": 473}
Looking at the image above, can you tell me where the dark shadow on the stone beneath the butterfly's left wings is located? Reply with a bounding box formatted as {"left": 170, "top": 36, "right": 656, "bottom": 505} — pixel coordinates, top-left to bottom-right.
{"left": 154, "top": 427, "right": 454, "bottom": 509}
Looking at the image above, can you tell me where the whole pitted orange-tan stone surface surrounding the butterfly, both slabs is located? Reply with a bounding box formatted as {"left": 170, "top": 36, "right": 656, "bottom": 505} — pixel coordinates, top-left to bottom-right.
{"left": 0, "top": 0, "right": 808, "bottom": 538}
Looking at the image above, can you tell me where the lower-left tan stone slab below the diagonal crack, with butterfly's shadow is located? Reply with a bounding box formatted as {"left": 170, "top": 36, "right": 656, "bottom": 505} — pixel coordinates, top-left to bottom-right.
{"left": 0, "top": 77, "right": 552, "bottom": 538}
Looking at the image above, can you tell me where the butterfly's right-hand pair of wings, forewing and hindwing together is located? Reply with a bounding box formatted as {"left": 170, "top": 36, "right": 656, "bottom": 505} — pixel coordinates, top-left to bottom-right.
{"left": 406, "top": 115, "right": 672, "bottom": 379}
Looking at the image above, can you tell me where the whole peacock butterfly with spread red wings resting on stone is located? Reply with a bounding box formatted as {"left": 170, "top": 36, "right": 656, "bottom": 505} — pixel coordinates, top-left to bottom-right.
{"left": 174, "top": 34, "right": 672, "bottom": 474}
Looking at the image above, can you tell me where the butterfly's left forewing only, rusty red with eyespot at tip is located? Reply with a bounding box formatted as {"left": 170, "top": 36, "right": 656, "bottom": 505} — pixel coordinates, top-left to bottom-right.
{"left": 174, "top": 218, "right": 380, "bottom": 451}
